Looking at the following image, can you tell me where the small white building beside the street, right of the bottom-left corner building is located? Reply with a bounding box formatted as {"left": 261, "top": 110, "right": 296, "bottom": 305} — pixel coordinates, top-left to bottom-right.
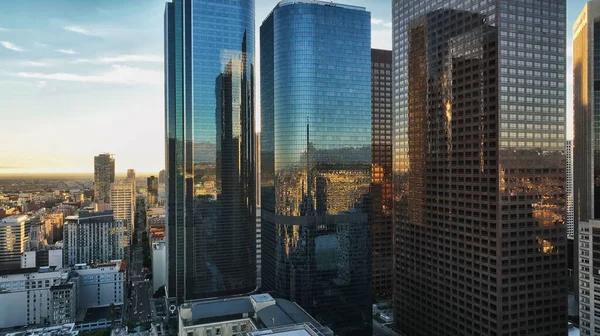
{"left": 73, "top": 261, "right": 125, "bottom": 310}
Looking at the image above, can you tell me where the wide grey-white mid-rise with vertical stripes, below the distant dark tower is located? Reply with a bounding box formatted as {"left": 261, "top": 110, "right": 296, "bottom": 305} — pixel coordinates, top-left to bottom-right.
{"left": 63, "top": 210, "right": 128, "bottom": 267}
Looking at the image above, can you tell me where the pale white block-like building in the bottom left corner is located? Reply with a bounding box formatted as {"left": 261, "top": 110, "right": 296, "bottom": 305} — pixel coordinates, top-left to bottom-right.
{"left": 0, "top": 267, "right": 77, "bottom": 328}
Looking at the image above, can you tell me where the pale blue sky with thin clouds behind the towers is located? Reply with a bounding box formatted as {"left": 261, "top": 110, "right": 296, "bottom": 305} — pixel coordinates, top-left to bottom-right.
{"left": 0, "top": 0, "right": 585, "bottom": 174}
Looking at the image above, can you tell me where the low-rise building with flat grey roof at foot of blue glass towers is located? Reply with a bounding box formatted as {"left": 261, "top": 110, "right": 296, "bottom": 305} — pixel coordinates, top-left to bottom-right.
{"left": 179, "top": 294, "right": 333, "bottom": 336}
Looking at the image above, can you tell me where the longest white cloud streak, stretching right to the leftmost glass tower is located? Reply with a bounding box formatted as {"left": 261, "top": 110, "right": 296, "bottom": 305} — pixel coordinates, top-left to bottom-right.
{"left": 16, "top": 65, "right": 163, "bottom": 85}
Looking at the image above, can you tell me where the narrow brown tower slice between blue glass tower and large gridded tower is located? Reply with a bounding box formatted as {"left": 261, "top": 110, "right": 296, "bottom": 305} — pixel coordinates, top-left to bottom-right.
{"left": 371, "top": 49, "right": 394, "bottom": 298}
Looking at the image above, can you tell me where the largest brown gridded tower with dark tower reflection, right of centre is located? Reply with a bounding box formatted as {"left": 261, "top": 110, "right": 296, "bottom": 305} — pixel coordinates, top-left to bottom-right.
{"left": 392, "top": 0, "right": 567, "bottom": 336}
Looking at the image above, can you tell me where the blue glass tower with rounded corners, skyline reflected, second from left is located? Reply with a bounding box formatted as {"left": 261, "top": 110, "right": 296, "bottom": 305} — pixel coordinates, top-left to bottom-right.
{"left": 260, "top": 1, "right": 372, "bottom": 335}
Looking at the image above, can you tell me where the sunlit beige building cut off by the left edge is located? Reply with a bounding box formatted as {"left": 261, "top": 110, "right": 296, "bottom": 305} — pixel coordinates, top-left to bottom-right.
{"left": 0, "top": 215, "right": 29, "bottom": 269}
